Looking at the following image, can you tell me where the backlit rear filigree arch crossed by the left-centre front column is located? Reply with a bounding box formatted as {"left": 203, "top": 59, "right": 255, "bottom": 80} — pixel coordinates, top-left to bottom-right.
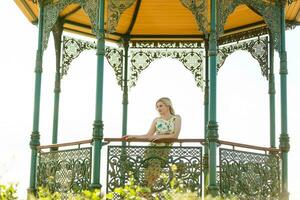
{"left": 61, "top": 36, "right": 123, "bottom": 87}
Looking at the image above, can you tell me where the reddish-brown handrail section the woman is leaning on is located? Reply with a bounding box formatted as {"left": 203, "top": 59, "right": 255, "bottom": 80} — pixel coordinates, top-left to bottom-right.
{"left": 104, "top": 138, "right": 205, "bottom": 144}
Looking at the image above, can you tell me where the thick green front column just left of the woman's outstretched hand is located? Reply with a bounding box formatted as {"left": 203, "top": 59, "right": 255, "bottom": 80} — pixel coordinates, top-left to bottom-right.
{"left": 91, "top": 0, "right": 105, "bottom": 189}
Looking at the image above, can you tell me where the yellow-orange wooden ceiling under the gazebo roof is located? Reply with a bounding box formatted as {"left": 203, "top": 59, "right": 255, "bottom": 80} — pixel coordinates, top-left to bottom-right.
{"left": 14, "top": 0, "right": 300, "bottom": 40}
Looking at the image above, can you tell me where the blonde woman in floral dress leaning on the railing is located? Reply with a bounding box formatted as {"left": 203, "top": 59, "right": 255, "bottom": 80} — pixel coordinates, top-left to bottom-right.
{"left": 123, "top": 97, "right": 181, "bottom": 190}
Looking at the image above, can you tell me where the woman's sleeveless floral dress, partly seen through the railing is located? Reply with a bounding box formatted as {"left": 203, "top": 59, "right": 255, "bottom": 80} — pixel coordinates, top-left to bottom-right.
{"left": 144, "top": 116, "right": 176, "bottom": 191}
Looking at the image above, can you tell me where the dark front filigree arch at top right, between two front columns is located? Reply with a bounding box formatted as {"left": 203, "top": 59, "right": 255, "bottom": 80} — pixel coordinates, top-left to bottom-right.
{"left": 217, "top": 0, "right": 280, "bottom": 51}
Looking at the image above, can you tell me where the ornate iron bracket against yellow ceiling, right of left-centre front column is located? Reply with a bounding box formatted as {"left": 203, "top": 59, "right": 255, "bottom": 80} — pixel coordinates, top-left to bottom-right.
{"left": 107, "top": 0, "right": 136, "bottom": 33}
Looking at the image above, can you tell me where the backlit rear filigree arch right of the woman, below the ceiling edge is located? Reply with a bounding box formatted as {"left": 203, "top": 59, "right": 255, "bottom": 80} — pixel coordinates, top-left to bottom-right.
{"left": 217, "top": 36, "right": 269, "bottom": 80}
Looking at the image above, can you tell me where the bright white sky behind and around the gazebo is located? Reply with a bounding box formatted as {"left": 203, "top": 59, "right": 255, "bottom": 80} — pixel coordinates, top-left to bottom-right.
{"left": 0, "top": 0, "right": 300, "bottom": 200}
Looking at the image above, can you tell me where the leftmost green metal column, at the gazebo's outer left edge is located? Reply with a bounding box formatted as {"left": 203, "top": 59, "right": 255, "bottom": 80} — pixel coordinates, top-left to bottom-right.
{"left": 28, "top": 1, "right": 44, "bottom": 194}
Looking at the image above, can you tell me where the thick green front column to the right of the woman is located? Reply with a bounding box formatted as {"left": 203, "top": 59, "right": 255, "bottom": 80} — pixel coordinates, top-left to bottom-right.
{"left": 207, "top": 0, "right": 219, "bottom": 196}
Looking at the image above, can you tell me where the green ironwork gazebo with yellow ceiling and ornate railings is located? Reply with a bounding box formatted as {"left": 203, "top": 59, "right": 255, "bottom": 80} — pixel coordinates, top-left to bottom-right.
{"left": 15, "top": 0, "right": 300, "bottom": 199}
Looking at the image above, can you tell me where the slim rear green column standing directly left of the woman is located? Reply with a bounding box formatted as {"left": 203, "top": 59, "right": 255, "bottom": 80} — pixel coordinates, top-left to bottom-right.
{"left": 122, "top": 37, "right": 129, "bottom": 142}
